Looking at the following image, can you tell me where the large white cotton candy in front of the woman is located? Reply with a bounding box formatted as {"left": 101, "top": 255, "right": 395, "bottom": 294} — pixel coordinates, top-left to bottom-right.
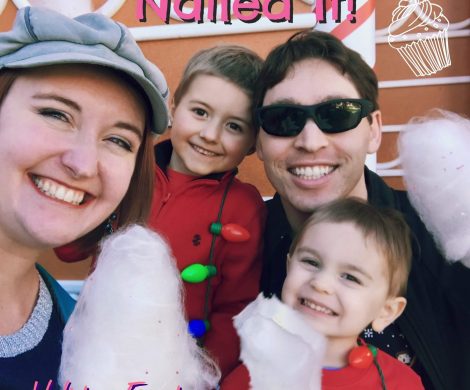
{"left": 60, "top": 226, "right": 219, "bottom": 390}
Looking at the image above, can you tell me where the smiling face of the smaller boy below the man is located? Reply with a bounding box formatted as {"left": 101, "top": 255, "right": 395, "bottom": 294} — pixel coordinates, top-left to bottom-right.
{"left": 282, "top": 222, "right": 404, "bottom": 354}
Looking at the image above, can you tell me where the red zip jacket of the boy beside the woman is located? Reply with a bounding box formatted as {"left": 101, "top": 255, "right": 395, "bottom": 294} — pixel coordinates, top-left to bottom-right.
{"left": 149, "top": 141, "right": 265, "bottom": 374}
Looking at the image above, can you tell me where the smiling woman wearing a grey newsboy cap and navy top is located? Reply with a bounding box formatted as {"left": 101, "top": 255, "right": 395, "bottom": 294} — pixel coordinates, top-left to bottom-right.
{"left": 0, "top": 8, "right": 168, "bottom": 389}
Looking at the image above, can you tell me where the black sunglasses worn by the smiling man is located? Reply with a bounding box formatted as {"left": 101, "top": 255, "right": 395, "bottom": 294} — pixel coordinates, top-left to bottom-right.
{"left": 256, "top": 99, "right": 374, "bottom": 137}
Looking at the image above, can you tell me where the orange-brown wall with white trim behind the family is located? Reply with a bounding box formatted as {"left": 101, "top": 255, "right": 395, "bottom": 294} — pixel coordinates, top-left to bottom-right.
{"left": 0, "top": 0, "right": 470, "bottom": 279}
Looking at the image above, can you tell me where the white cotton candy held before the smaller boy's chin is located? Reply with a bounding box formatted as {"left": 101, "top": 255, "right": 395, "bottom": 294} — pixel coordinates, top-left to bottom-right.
{"left": 234, "top": 294, "right": 326, "bottom": 390}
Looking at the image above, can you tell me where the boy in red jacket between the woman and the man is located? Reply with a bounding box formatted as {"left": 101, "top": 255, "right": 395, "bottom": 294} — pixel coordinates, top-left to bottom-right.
{"left": 149, "top": 45, "right": 265, "bottom": 374}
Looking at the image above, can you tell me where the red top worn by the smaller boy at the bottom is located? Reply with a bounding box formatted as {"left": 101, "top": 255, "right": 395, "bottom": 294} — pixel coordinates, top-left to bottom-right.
{"left": 220, "top": 349, "right": 424, "bottom": 390}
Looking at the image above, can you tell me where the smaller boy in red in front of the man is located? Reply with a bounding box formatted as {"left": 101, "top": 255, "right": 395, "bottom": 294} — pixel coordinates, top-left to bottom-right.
{"left": 222, "top": 198, "right": 423, "bottom": 390}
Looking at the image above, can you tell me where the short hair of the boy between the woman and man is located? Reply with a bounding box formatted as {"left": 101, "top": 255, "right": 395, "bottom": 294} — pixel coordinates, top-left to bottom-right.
{"left": 174, "top": 45, "right": 263, "bottom": 114}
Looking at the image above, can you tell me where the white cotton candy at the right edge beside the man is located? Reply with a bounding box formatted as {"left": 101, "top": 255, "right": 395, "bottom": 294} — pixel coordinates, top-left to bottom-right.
{"left": 399, "top": 110, "right": 470, "bottom": 267}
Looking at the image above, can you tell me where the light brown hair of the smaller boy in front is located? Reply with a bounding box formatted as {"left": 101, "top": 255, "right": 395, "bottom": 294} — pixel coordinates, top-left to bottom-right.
{"left": 289, "top": 198, "right": 412, "bottom": 297}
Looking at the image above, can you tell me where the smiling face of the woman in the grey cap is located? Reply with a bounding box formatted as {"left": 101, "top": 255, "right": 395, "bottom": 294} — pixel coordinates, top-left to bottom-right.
{"left": 0, "top": 65, "right": 145, "bottom": 248}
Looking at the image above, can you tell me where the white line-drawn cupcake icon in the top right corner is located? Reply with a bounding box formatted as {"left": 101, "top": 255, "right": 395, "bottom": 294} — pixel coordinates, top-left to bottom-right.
{"left": 388, "top": 0, "right": 451, "bottom": 77}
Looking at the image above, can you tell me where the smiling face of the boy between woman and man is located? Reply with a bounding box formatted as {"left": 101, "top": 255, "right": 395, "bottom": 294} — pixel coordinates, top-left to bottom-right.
{"left": 169, "top": 74, "right": 255, "bottom": 176}
